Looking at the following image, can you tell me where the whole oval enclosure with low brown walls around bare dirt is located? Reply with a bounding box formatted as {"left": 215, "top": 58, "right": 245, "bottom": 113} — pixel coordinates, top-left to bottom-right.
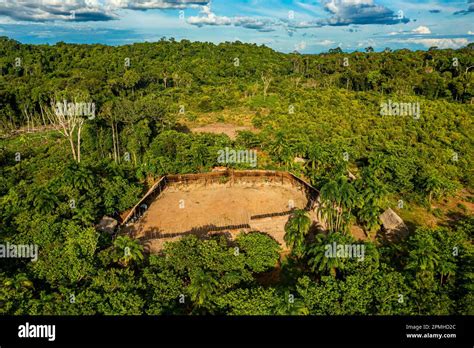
{"left": 121, "top": 169, "right": 321, "bottom": 252}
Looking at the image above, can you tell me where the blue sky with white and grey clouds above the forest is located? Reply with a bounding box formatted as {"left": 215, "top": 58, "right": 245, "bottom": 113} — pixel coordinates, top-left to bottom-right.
{"left": 0, "top": 0, "right": 474, "bottom": 53}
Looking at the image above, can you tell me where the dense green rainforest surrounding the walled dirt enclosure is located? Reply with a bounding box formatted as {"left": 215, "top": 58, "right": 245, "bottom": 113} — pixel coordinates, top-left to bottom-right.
{"left": 0, "top": 37, "right": 474, "bottom": 315}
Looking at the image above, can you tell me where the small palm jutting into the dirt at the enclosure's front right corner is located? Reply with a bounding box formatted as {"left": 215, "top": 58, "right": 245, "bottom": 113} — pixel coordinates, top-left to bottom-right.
{"left": 284, "top": 209, "right": 311, "bottom": 255}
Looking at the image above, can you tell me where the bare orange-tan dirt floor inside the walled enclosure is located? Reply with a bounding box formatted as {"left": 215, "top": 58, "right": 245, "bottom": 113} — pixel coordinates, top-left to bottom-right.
{"left": 126, "top": 181, "right": 317, "bottom": 251}
